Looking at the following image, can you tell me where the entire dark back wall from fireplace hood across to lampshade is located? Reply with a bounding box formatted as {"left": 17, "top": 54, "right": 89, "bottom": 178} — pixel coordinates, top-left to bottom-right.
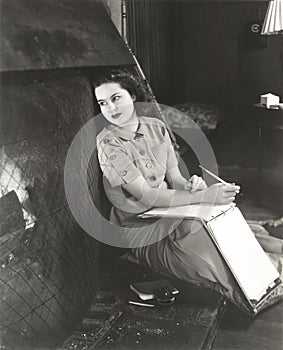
{"left": 128, "top": 0, "right": 283, "bottom": 118}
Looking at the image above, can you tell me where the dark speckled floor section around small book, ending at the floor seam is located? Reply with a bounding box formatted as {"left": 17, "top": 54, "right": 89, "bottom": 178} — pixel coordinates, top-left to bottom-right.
{"left": 61, "top": 260, "right": 229, "bottom": 350}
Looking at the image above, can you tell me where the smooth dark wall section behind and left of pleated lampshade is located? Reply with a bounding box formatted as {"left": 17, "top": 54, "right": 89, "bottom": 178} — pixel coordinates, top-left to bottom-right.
{"left": 183, "top": 1, "right": 283, "bottom": 117}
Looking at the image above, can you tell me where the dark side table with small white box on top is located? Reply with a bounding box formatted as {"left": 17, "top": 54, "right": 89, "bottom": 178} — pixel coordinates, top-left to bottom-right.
{"left": 254, "top": 103, "right": 283, "bottom": 205}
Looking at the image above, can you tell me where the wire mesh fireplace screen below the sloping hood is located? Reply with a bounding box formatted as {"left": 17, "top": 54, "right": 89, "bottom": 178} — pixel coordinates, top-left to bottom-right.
{"left": 0, "top": 73, "right": 100, "bottom": 349}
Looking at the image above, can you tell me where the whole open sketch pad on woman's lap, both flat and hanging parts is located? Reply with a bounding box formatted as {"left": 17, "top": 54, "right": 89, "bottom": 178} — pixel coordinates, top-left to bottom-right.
{"left": 142, "top": 205, "right": 281, "bottom": 313}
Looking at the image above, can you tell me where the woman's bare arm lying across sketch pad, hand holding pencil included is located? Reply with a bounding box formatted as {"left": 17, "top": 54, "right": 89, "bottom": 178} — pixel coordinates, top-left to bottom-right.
{"left": 122, "top": 176, "right": 240, "bottom": 208}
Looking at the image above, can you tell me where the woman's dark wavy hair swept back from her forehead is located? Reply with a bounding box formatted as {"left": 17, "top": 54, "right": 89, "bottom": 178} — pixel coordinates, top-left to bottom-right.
{"left": 93, "top": 69, "right": 151, "bottom": 102}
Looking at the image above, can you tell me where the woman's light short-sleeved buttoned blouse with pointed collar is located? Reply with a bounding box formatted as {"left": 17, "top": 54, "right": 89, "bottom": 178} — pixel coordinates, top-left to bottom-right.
{"left": 97, "top": 117, "right": 178, "bottom": 187}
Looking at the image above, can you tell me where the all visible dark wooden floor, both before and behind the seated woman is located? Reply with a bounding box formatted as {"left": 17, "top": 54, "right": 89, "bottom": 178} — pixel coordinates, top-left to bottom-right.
{"left": 60, "top": 166, "right": 283, "bottom": 350}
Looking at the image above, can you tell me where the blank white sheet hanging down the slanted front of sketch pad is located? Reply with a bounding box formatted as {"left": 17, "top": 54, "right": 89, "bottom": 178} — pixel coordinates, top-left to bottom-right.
{"left": 207, "top": 208, "right": 279, "bottom": 301}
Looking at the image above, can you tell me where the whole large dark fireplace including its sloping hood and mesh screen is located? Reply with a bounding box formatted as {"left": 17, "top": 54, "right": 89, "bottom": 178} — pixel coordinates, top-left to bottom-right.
{"left": 0, "top": 0, "right": 134, "bottom": 349}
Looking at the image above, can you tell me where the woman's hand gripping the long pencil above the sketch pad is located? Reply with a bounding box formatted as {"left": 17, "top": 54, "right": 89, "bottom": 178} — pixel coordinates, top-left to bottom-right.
{"left": 203, "top": 183, "right": 240, "bottom": 204}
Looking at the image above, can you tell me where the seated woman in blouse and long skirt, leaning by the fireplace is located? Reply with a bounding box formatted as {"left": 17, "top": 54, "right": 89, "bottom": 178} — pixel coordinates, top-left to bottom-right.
{"left": 94, "top": 71, "right": 282, "bottom": 311}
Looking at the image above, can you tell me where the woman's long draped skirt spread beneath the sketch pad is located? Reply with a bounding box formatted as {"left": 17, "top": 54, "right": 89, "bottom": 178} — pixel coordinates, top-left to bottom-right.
{"left": 131, "top": 220, "right": 283, "bottom": 313}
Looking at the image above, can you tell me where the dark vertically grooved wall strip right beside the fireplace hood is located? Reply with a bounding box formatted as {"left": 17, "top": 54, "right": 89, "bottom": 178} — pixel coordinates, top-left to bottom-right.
{"left": 127, "top": 0, "right": 184, "bottom": 104}
